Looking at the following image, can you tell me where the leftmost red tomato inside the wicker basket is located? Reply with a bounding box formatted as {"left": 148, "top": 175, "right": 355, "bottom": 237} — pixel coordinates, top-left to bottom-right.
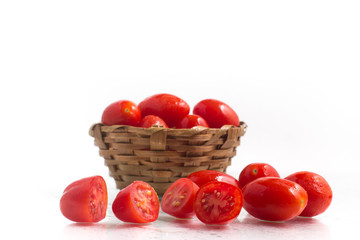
{"left": 101, "top": 100, "right": 141, "bottom": 126}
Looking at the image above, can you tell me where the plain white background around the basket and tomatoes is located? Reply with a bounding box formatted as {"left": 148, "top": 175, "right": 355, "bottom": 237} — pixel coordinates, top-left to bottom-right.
{"left": 0, "top": 0, "right": 360, "bottom": 239}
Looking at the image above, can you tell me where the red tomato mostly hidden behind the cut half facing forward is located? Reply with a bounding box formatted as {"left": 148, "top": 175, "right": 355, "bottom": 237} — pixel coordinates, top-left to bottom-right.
{"left": 187, "top": 170, "right": 240, "bottom": 187}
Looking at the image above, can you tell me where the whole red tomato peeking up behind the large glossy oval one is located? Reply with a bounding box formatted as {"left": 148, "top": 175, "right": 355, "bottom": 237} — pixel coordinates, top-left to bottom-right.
{"left": 239, "top": 163, "right": 280, "bottom": 188}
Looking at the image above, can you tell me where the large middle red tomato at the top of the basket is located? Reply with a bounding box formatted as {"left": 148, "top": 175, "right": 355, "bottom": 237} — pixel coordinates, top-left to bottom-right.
{"left": 139, "top": 93, "right": 190, "bottom": 128}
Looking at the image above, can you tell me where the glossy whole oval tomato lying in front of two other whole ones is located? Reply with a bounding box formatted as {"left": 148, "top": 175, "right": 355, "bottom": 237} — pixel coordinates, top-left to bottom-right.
{"left": 243, "top": 177, "right": 308, "bottom": 221}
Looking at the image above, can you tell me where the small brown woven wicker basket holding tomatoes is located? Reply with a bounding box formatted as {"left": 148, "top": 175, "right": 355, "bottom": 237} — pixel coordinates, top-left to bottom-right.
{"left": 89, "top": 122, "right": 247, "bottom": 196}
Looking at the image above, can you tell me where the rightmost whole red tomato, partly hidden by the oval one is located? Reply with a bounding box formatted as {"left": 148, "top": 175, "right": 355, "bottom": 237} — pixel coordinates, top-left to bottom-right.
{"left": 285, "top": 171, "right": 332, "bottom": 217}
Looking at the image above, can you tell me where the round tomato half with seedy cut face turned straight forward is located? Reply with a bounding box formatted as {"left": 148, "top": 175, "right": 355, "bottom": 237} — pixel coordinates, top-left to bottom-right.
{"left": 194, "top": 181, "right": 243, "bottom": 224}
